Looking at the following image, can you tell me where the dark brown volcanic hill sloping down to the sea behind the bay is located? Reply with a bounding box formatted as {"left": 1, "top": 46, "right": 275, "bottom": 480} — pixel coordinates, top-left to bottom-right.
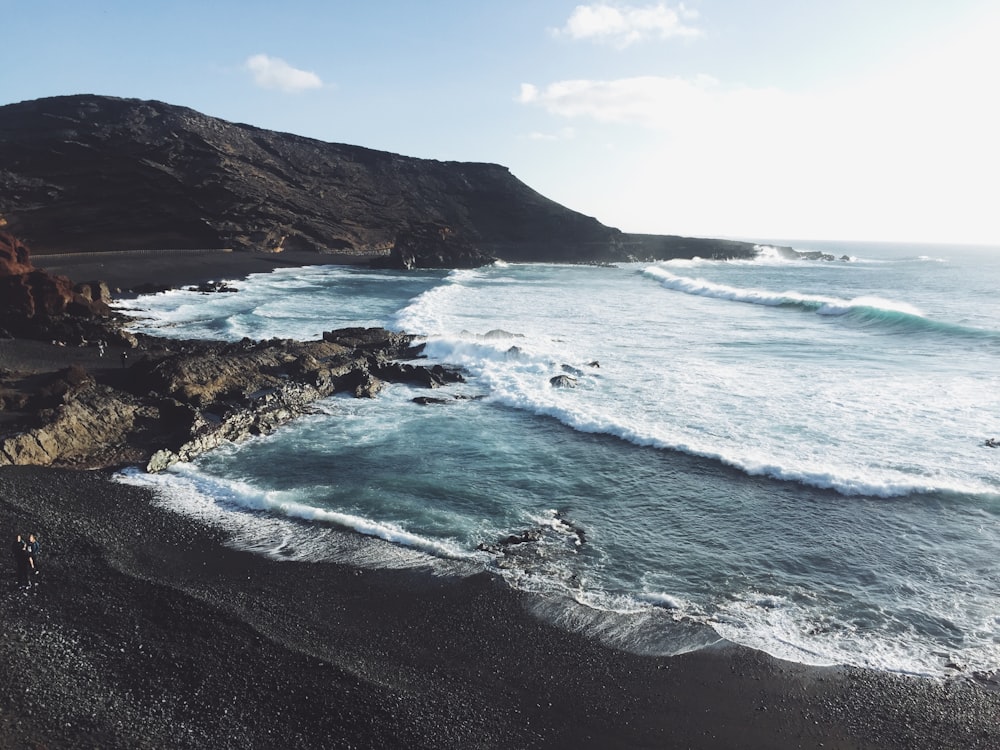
{"left": 0, "top": 95, "right": 752, "bottom": 265}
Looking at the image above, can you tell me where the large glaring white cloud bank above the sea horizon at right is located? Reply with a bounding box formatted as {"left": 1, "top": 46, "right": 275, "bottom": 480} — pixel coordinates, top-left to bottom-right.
{"left": 518, "top": 41, "right": 1000, "bottom": 242}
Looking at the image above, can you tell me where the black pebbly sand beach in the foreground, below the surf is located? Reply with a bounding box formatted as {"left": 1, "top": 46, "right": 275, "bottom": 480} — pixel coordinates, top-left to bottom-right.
{"left": 0, "top": 250, "right": 1000, "bottom": 750}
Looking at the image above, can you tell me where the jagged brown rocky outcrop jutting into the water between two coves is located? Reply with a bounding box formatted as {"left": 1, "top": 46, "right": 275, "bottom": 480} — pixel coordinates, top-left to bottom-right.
{"left": 0, "top": 328, "right": 461, "bottom": 471}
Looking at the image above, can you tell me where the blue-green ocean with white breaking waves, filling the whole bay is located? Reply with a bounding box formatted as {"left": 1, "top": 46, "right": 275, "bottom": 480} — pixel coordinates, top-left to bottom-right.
{"left": 113, "top": 242, "right": 1000, "bottom": 677}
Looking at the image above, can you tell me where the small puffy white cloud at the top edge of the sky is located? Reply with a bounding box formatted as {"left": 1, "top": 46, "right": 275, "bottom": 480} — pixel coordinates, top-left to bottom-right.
{"left": 555, "top": 3, "right": 701, "bottom": 48}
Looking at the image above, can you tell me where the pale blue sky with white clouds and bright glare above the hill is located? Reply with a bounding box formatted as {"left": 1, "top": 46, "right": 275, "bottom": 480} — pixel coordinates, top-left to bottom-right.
{"left": 0, "top": 0, "right": 1000, "bottom": 245}
